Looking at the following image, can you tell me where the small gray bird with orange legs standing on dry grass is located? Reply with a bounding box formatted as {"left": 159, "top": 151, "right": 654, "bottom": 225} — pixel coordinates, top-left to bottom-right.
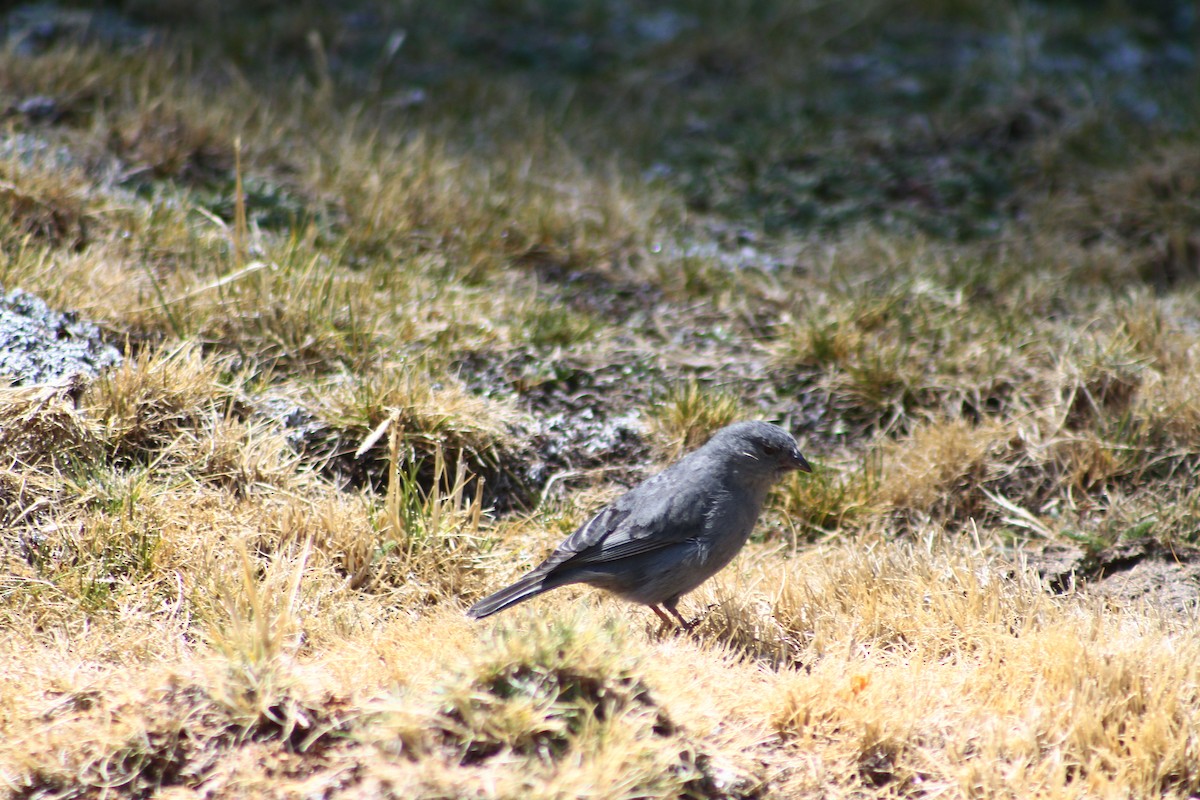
{"left": 467, "top": 422, "right": 812, "bottom": 630}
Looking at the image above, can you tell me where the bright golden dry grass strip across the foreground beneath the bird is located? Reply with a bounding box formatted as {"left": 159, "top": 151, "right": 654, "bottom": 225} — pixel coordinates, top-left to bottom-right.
{"left": 9, "top": 542, "right": 1200, "bottom": 798}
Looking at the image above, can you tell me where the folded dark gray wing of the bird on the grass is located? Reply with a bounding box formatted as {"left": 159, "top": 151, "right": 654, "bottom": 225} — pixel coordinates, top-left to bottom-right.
{"left": 539, "top": 463, "right": 714, "bottom": 572}
